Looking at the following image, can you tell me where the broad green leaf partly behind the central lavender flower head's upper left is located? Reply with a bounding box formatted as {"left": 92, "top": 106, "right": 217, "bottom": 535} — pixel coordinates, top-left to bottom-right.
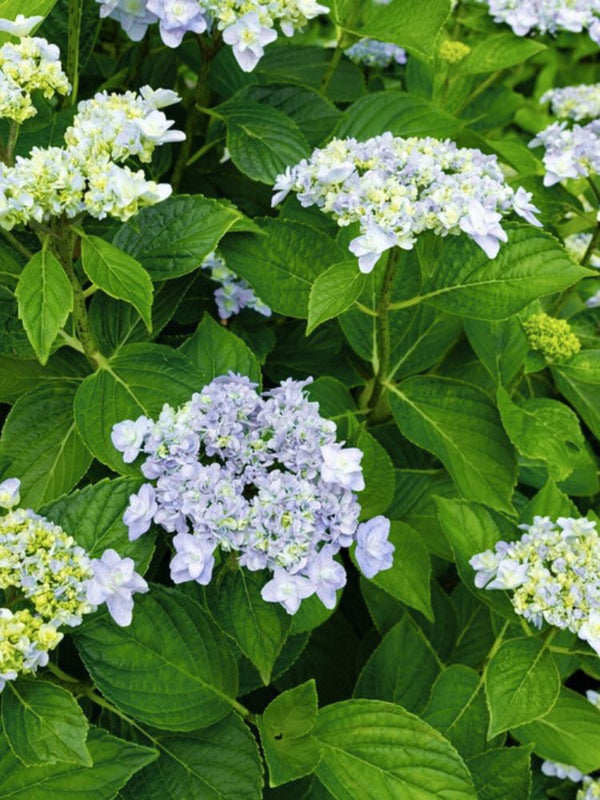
{"left": 75, "top": 344, "right": 204, "bottom": 475}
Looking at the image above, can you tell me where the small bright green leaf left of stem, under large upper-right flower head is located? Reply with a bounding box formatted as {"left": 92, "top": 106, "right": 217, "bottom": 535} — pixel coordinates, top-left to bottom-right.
{"left": 306, "top": 260, "right": 365, "bottom": 336}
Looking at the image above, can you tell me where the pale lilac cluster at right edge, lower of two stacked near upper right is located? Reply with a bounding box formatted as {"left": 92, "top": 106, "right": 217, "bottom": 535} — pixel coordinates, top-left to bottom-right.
{"left": 529, "top": 120, "right": 600, "bottom": 186}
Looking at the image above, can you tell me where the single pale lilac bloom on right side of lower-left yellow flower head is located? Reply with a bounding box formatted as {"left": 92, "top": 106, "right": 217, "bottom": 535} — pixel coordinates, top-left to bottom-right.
{"left": 87, "top": 549, "right": 148, "bottom": 627}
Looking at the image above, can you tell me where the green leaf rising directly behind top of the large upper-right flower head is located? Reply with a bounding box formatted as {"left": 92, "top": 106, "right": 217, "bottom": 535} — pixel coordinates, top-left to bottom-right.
{"left": 336, "top": 91, "right": 464, "bottom": 142}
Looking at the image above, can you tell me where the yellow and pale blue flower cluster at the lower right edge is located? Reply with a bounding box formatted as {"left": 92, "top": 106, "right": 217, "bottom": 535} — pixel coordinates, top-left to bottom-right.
{"left": 469, "top": 516, "right": 600, "bottom": 654}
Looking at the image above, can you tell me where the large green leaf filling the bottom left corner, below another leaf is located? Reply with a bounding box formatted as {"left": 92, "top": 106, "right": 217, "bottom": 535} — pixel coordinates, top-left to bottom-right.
{"left": 0, "top": 728, "right": 157, "bottom": 800}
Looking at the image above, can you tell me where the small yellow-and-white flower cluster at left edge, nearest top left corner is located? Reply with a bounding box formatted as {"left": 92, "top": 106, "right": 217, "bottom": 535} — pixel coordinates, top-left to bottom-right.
{"left": 0, "top": 14, "right": 71, "bottom": 124}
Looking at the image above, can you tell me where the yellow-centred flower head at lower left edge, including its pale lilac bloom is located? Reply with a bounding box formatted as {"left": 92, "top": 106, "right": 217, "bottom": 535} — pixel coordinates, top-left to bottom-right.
{"left": 0, "top": 478, "right": 148, "bottom": 691}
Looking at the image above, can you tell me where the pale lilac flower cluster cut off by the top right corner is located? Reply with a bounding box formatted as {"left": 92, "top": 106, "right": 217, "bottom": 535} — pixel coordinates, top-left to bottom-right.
{"left": 487, "top": 0, "right": 600, "bottom": 42}
